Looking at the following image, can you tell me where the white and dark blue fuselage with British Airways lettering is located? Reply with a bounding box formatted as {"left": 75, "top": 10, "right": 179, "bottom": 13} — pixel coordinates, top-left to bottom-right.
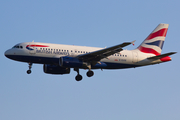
{"left": 5, "top": 42, "right": 161, "bottom": 69}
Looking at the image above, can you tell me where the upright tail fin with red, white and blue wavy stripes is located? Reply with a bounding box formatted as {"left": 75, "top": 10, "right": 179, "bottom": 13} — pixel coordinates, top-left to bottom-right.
{"left": 137, "top": 23, "right": 169, "bottom": 56}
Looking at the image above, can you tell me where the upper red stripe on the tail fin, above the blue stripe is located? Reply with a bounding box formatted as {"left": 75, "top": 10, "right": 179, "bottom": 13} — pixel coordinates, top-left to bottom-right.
{"left": 146, "top": 28, "right": 168, "bottom": 40}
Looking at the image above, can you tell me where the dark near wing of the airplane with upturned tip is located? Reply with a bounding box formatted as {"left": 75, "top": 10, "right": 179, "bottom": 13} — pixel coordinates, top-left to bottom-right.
{"left": 77, "top": 41, "right": 135, "bottom": 62}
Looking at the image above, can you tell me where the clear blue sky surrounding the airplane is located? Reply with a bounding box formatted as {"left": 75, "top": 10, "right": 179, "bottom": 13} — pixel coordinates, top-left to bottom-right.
{"left": 0, "top": 0, "right": 180, "bottom": 120}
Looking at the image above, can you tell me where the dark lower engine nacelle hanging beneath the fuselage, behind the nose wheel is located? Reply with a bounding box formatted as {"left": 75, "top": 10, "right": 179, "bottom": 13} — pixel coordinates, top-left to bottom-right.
{"left": 43, "top": 64, "right": 70, "bottom": 74}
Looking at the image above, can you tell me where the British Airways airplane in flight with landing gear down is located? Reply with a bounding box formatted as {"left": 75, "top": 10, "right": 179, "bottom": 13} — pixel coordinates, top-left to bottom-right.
{"left": 4, "top": 23, "right": 176, "bottom": 81}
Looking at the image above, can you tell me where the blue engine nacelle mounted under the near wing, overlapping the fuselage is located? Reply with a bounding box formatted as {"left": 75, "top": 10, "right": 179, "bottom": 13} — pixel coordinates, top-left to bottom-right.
{"left": 59, "top": 56, "right": 86, "bottom": 68}
